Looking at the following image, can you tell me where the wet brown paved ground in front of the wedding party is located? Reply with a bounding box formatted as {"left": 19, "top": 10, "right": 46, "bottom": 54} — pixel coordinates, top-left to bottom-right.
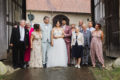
{"left": 8, "top": 67, "right": 95, "bottom": 80}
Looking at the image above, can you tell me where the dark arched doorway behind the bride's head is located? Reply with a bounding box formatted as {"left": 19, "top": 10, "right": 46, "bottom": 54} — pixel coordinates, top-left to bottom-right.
{"left": 53, "top": 15, "right": 69, "bottom": 26}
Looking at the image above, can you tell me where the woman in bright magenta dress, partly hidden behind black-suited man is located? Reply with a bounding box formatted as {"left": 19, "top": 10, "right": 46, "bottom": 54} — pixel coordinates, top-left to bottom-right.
{"left": 24, "top": 23, "right": 34, "bottom": 67}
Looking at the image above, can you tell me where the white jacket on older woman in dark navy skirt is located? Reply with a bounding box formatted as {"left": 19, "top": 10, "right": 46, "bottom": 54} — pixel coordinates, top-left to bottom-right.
{"left": 71, "top": 32, "right": 84, "bottom": 46}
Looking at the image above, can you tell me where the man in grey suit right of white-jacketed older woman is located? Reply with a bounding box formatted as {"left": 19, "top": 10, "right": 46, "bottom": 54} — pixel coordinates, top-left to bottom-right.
{"left": 82, "top": 24, "right": 91, "bottom": 65}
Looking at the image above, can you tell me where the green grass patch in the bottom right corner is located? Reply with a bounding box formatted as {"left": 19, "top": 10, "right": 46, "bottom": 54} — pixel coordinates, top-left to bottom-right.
{"left": 90, "top": 68, "right": 120, "bottom": 80}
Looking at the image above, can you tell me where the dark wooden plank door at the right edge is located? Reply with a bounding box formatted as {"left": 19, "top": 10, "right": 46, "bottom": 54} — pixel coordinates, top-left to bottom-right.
{"left": 105, "top": 0, "right": 120, "bottom": 57}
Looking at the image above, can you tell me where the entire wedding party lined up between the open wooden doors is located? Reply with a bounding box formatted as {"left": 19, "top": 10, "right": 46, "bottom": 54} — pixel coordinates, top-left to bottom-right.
{"left": 10, "top": 16, "right": 105, "bottom": 68}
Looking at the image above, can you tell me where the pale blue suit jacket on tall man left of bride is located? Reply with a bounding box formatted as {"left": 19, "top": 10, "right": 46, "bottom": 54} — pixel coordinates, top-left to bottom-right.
{"left": 40, "top": 23, "right": 52, "bottom": 42}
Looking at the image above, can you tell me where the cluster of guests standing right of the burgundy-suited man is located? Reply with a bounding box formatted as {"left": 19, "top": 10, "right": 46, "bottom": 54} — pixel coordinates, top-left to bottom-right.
{"left": 71, "top": 20, "right": 105, "bottom": 68}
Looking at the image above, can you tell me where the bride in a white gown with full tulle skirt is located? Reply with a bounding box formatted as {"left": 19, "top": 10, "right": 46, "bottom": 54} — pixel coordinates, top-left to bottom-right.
{"left": 47, "top": 21, "right": 67, "bottom": 67}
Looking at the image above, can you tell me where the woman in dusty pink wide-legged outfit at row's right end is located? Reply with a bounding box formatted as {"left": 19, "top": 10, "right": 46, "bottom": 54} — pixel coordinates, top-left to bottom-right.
{"left": 90, "top": 24, "right": 105, "bottom": 68}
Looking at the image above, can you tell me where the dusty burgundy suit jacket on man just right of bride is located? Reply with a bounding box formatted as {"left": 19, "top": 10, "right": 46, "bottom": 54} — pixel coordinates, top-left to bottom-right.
{"left": 62, "top": 25, "right": 72, "bottom": 43}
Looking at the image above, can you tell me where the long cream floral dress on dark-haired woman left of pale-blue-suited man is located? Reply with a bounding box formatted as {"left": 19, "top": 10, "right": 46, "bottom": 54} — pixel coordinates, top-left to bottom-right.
{"left": 29, "top": 31, "right": 43, "bottom": 68}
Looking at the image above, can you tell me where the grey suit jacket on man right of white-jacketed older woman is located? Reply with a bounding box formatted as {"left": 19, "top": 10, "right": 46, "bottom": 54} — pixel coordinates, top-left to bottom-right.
{"left": 82, "top": 30, "right": 91, "bottom": 48}
